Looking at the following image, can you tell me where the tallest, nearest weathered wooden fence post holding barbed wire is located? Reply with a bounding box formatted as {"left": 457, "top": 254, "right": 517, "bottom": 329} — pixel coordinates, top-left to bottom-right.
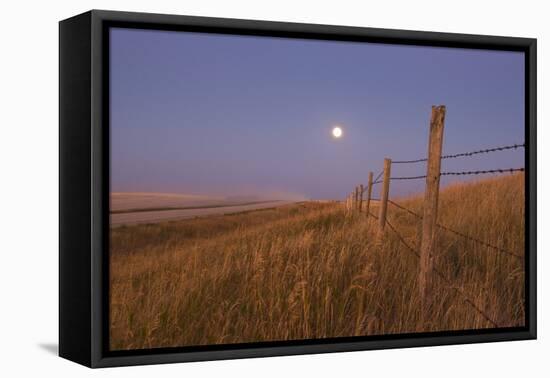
{"left": 418, "top": 105, "right": 445, "bottom": 324}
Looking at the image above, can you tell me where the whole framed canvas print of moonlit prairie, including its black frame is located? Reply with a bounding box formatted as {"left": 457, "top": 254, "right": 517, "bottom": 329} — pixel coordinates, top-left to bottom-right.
{"left": 59, "top": 10, "right": 536, "bottom": 367}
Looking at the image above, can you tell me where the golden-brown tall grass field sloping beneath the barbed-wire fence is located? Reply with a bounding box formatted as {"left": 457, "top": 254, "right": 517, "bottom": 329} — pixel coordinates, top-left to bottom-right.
{"left": 110, "top": 174, "right": 525, "bottom": 350}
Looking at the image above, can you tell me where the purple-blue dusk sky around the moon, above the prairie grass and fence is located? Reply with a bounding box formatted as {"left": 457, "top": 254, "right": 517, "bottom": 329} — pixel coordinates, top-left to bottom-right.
{"left": 110, "top": 29, "right": 524, "bottom": 199}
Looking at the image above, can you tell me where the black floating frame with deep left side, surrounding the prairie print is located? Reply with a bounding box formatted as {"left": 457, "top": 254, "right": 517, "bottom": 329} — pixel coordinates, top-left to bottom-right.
{"left": 59, "top": 10, "right": 537, "bottom": 368}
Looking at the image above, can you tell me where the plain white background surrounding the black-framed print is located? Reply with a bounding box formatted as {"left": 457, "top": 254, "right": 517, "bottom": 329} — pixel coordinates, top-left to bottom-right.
{"left": 0, "top": 0, "right": 550, "bottom": 378}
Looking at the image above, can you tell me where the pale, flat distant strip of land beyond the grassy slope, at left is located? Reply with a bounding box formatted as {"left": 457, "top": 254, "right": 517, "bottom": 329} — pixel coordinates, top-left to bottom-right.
{"left": 110, "top": 193, "right": 294, "bottom": 227}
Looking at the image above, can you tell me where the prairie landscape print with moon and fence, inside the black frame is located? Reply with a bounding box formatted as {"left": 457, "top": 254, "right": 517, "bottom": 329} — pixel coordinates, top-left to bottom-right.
{"left": 108, "top": 28, "right": 526, "bottom": 351}
